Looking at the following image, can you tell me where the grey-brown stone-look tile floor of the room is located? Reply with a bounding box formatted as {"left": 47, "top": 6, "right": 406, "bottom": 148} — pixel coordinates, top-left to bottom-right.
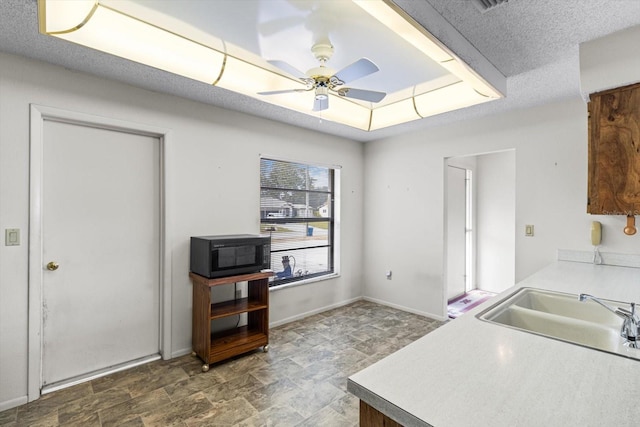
{"left": 0, "top": 301, "right": 442, "bottom": 427}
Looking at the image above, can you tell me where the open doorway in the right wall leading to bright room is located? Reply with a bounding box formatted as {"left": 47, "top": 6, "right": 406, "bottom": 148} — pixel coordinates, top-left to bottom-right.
{"left": 444, "top": 150, "right": 515, "bottom": 318}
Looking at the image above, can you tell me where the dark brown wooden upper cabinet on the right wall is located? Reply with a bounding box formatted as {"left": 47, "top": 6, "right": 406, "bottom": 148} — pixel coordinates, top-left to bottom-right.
{"left": 587, "top": 83, "right": 640, "bottom": 215}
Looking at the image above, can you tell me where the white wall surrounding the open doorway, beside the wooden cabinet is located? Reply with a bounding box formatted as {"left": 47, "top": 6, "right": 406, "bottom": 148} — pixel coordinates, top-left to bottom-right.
{"left": 364, "top": 96, "right": 640, "bottom": 318}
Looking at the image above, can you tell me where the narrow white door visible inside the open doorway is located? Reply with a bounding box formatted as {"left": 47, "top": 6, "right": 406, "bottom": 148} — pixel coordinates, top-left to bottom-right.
{"left": 446, "top": 166, "right": 467, "bottom": 300}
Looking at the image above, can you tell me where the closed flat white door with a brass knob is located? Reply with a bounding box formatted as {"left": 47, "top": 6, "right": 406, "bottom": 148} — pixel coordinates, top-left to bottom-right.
{"left": 42, "top": 120, "right": 161, "bottom": 387}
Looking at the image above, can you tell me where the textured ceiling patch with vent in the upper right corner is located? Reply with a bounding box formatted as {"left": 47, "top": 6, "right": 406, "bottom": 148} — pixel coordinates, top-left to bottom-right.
{"left": 428, "top": 0, "right": 640, "bottom": 76}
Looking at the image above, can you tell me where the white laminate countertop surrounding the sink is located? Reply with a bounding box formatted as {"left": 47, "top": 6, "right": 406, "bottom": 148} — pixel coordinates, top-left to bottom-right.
{"left": 347, "top": 261, "right": 640, "bottom": 427}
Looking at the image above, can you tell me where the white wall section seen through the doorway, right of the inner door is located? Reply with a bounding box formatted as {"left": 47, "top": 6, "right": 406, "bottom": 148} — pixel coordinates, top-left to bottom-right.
{"left": 474, "top": 150, "right": 516, "bottom": 293}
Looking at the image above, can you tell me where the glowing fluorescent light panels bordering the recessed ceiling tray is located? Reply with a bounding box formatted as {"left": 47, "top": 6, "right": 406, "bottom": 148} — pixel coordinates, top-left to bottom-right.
{"left": 38, "top": 0, "right": 503, "bottom": 131}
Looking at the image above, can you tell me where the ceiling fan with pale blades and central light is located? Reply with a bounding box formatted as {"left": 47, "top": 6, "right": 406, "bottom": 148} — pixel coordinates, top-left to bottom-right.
{"left": 258, "top": 40, "right": 387, "bottom": 111}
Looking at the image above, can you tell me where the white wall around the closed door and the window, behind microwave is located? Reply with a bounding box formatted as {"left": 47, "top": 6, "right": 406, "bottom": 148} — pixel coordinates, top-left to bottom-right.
{"left": 0, "top": 54, "right": 363, "bottom": 410}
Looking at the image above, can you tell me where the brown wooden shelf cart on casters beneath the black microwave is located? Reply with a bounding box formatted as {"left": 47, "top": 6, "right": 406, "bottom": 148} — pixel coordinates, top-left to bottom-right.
{"left": 189, "top": 272, "right": 273, "bottom": 372}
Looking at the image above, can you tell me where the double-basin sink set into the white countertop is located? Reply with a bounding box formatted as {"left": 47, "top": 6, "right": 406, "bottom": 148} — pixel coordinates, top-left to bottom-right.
{"left": 476, "top": 288, "right": 640, "bottom": 360}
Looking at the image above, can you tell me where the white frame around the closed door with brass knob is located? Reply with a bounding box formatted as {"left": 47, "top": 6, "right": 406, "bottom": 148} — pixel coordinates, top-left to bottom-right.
{"left": 27, "top": 104, "right": 173, "bottom": 402}
